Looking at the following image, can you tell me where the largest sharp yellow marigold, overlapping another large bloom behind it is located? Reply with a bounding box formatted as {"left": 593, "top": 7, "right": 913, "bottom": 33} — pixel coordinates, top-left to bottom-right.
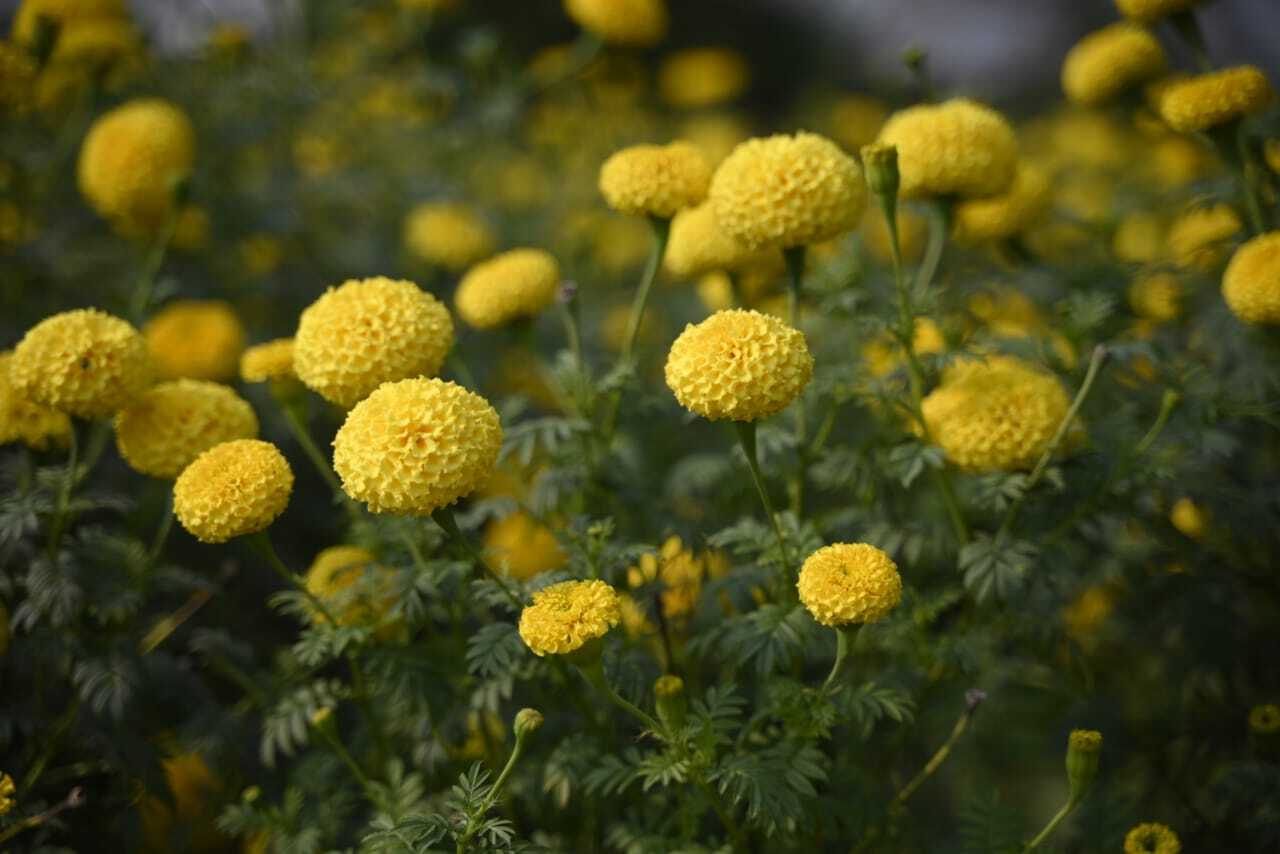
{"left": 333, "top": 379, "right": 502, "bottom": 516}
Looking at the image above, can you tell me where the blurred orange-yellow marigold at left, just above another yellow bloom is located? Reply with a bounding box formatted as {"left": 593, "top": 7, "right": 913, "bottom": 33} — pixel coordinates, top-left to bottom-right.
{"left": 142, "top": 300, "right": 244, "bottom": 382}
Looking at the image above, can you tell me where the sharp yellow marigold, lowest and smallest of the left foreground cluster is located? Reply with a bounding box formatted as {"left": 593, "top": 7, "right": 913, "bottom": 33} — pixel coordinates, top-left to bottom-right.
{"left": 173, "top": 439, "right": 293, "bottom": 543}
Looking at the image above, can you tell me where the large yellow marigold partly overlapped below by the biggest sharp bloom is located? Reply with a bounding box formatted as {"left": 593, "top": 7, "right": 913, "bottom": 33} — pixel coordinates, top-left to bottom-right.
{"left": 293, "top": 278, "right": 453, "bottom": 407}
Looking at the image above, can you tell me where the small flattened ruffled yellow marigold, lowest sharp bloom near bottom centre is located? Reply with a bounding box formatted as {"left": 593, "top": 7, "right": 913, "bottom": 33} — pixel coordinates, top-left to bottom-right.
{"left": 520, "top": 580, "right": 622, "bottom": 656}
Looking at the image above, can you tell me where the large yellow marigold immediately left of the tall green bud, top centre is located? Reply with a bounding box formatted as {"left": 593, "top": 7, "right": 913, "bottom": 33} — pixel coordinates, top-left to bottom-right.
{"left": 710, "top": 133, "right": 867, "bottom": 248}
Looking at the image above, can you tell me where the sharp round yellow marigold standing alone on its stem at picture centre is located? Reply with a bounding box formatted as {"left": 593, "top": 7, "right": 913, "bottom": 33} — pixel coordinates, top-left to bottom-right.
{"left": 667, "top": 309, "right": 813, "bottom": 421}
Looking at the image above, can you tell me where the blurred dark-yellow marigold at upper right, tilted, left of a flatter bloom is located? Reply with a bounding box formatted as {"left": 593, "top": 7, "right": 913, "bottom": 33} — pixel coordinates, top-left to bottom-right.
{"left": 1062, "top": 22, "right": 1165, "bottom": 106}
